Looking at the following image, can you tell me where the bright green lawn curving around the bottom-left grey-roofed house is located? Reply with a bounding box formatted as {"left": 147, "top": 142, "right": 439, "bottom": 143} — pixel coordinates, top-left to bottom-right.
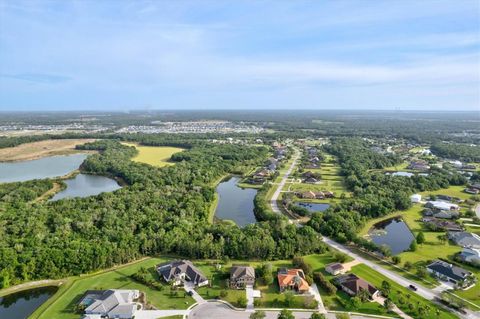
{"left": 31, "top": 258, "right": 194, "bottom": 319}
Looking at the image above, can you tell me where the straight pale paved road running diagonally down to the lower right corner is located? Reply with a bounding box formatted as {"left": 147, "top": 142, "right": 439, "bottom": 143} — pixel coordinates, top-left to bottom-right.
{"left": 323, "top": 237, "right": 480, "bottom": 319}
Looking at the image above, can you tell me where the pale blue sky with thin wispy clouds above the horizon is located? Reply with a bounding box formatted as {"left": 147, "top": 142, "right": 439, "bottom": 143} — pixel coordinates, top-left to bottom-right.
{"left": 0, "top": 0, "right": 480, "bottom": 110}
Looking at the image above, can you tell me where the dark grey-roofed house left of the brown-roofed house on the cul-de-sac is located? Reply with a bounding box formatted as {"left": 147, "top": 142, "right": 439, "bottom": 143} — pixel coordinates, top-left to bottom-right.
{"left": 157, "top": 260, "right": 208, "bottom": 287}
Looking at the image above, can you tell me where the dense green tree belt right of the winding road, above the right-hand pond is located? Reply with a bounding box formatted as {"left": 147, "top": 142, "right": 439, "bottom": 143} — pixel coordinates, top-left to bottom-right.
{"left": 309, "top": 138, "right": 466, "bottom": 249}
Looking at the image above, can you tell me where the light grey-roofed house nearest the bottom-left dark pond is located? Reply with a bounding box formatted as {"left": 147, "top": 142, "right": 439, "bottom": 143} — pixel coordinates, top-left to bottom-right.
{"left": 80, "top": 289, "right": 142, "bottom": 319}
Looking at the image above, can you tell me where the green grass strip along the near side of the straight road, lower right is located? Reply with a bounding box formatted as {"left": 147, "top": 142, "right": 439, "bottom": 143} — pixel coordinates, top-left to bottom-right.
{"left": 352, "top": 264, "right": 456, "bottom": 319}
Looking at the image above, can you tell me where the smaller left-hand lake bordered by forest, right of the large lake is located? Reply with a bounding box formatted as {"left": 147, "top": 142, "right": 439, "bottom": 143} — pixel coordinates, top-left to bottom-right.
{"left": 50, "top": 174, "right": 121, "bottom": 201}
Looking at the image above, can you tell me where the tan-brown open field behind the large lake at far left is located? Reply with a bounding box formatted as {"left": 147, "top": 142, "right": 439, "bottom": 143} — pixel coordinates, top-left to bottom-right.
{"left": 0, "top": 139, "right": 94, "bottom": 162}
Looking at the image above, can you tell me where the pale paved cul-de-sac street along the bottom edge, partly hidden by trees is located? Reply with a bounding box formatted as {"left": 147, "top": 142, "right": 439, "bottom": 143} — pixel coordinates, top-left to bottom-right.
{"left": 188, "top": 302, "right": 386, "bottom": 319}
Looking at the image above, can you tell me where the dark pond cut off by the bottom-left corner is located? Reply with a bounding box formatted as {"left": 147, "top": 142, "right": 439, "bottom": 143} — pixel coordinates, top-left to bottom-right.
{"left": 0, "top": 287, "right": 58, "bottom": 319}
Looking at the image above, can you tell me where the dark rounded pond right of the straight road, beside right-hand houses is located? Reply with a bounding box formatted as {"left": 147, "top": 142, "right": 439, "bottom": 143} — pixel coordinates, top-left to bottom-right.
{"left": 369, "top": 218, "right": 414, "bottom": 255}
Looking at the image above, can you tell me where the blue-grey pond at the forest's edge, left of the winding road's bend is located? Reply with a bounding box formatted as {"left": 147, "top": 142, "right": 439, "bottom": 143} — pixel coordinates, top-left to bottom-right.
{"left": 215, "top": 176, "right": 257, "bottom": 227}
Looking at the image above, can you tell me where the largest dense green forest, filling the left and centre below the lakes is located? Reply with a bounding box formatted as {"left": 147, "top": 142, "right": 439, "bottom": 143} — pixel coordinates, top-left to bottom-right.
{"left": 0, "top": 136, "right": 326, "bottom": 288}
